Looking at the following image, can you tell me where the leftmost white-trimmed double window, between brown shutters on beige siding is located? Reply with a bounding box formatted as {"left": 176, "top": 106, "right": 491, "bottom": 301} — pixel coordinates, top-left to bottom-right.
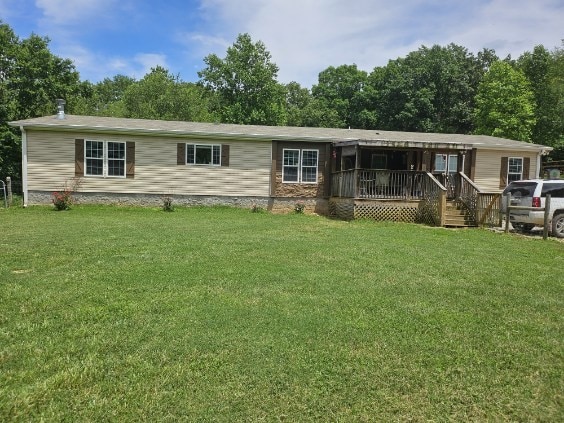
{"left": 84, "top": 140, "right": 126, "bottom": 178}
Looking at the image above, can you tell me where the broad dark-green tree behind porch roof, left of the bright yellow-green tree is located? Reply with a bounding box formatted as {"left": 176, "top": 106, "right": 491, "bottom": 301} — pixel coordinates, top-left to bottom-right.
{"left": 364, "top": 44, "right": 495, "bottom": 133}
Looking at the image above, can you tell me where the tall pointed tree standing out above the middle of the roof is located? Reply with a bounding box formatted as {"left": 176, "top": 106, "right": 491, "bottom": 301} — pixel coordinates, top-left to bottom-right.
{"left": 198, "top": 34, "right": 286, "bottom": 125}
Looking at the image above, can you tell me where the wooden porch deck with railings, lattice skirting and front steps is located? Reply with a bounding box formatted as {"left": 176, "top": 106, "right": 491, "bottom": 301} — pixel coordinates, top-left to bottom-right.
{"left": 329, "top": 169, "right": 501, "bottom": 227}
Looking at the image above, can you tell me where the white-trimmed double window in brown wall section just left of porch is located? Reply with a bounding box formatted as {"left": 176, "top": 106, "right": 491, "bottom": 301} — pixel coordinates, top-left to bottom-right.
{"left": 282, "top": 148, "right": 319, "bottom": 184}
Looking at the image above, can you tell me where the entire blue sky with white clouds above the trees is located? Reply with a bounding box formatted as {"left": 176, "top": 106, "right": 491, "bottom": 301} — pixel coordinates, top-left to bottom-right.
{"left": 0, "top": 0, "right": 564, "bottom": 88}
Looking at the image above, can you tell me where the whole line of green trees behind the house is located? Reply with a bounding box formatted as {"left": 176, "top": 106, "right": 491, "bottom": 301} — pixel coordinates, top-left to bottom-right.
{"left": 0, "top": 21, "right": 564, "bottom": 179}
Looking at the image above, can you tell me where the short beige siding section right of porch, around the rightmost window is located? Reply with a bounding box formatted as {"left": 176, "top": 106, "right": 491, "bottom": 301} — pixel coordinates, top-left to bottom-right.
{"left": 474, "top": 150, "right": 537, "bottom": 192}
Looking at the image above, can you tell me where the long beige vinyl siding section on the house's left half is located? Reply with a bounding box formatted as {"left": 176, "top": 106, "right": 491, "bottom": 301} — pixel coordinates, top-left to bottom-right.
{"left": 27, "top": 131, "right": 271, "bottom": 196}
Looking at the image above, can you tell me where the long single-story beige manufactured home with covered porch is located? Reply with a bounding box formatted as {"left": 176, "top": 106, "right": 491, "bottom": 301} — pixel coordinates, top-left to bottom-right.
{"left": 10, "top": 113, "right": 551, "bottom": 226}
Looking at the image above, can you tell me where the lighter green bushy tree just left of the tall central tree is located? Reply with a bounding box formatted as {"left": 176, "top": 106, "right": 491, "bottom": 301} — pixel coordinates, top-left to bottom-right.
{"left": 123, "top": 66, "right": 213, "bottom": 122}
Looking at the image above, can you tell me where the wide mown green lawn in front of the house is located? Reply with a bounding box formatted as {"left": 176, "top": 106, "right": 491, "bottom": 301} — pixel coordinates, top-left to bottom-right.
{"left": 0, "top": 206, "right": 564, "bottom": 421}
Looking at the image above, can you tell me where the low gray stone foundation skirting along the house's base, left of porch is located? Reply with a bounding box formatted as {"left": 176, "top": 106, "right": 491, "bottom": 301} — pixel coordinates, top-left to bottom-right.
{"left": 28, "top": 191, "right": 329, "bottom": 215}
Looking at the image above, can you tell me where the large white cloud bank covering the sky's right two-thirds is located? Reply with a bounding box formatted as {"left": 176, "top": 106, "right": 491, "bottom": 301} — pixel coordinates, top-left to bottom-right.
{"left": 193, "top": 0, "right": 564, "bottom": 86}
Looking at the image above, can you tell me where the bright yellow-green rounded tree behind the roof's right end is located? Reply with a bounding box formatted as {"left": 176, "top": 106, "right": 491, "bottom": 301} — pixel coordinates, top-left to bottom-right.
{"left": 475, "top": 61, "right": 535, "bottom": 141}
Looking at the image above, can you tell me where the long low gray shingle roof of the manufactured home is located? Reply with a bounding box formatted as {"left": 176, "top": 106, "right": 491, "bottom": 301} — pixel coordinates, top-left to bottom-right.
{"left": 10, "top": 114, "right": 552, "bottom": 152}
